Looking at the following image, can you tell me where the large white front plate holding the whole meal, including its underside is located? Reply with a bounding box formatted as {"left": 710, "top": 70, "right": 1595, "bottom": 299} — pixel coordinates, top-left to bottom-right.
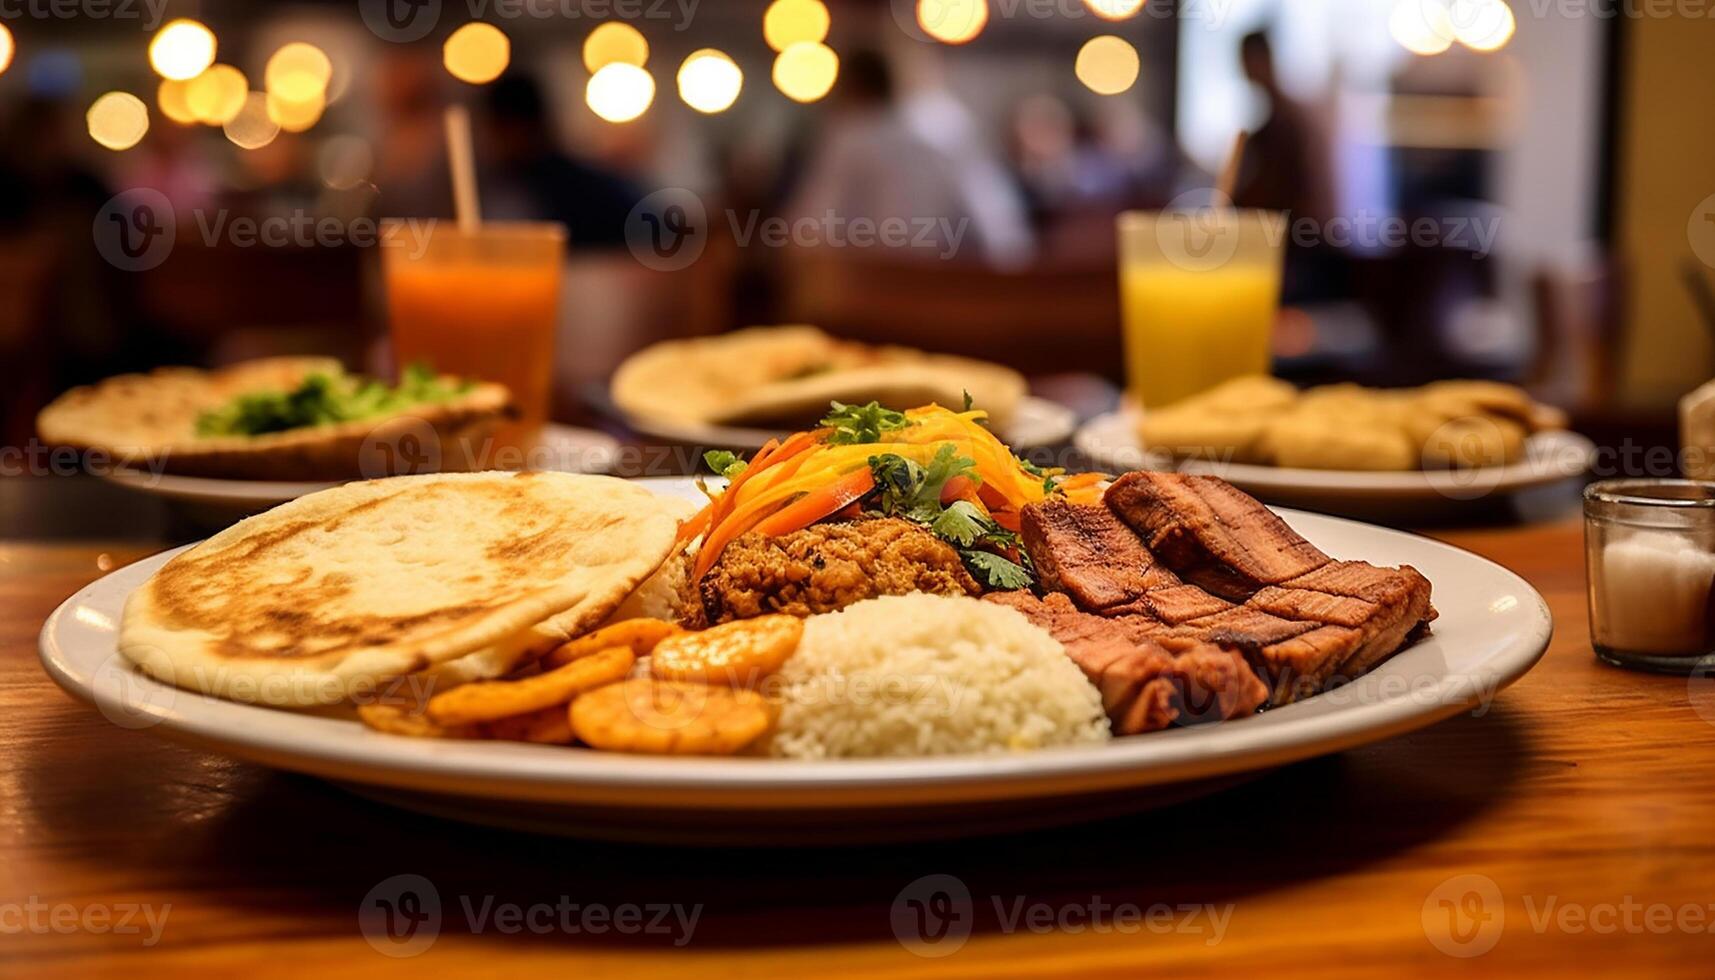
{"left": 41, "top": 479, "right": 1552, "bottom": 843}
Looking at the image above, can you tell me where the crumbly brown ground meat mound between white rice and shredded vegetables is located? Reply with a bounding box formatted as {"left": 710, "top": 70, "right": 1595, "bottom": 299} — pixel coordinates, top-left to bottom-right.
{"left": 686, "top": 518, "right": 983, "bottom": 625}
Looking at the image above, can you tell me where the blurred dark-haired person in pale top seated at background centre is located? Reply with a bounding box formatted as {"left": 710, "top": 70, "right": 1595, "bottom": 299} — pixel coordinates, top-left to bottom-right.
{"left": 787, "top": 50, "right": 1034, "bottom": 268}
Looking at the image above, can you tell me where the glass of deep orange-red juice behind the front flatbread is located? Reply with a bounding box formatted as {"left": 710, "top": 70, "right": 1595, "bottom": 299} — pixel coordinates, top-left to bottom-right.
{"left": 381, "top": 221, "right": 566, "bottom": 455}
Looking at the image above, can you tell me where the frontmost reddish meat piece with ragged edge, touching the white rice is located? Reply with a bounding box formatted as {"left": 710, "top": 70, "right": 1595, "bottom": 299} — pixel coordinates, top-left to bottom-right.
{"left": 988, "top": 592, "right": 1267, "bottom": 735}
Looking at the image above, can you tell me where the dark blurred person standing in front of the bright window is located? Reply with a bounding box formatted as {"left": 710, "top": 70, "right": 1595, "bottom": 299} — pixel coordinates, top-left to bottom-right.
{"left": 1233, "top": 31, "right": 1334, "bottom": 221}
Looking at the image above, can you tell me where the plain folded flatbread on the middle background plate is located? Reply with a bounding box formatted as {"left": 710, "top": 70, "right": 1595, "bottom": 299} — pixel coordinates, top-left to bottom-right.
{"left": 612, "top": 326, "right": 1027, "bottom": 427}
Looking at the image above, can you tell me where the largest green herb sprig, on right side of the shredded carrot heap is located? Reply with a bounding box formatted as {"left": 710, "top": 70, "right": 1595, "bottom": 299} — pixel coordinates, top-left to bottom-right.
{"left": 870, "top": 443, "right": 1031, "bottom": 589}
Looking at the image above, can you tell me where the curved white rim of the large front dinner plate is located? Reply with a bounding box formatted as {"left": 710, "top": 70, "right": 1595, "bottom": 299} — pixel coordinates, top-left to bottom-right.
{"left": 38, "top": 477, "right": 1554, "bottom": 810}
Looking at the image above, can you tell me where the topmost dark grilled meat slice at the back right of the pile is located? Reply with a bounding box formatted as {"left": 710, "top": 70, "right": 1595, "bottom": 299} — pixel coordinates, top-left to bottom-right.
{"left": 1104, "top": 472, "right": 1329, "bottom": 602}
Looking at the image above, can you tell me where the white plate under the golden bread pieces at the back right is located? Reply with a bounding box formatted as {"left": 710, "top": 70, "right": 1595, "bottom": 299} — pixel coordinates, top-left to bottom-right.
{"left": 1074, "top": 410, "right": 1595, "bottom": 510}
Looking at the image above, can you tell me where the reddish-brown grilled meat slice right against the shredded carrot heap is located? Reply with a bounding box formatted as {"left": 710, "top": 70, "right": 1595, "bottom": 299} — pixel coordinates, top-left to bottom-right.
{"left": 1020, "top": 499, "right": 1180, "bottom": 611}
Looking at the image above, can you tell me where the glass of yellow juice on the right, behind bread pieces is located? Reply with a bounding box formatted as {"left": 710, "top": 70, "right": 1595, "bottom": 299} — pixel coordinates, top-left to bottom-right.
{"left": 1118, "top": 208, "right": 1286, "bottom": 408}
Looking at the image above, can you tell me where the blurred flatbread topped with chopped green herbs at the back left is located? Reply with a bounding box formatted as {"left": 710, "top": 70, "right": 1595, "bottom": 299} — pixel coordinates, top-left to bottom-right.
{"left": 36, "top": 357, "right": 511, "bottom": 481}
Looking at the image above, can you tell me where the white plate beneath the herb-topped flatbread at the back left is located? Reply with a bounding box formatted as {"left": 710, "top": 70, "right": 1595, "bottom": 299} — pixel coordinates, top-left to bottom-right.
{"left": 90, "top": 424, "right": 619, "bottom": 513}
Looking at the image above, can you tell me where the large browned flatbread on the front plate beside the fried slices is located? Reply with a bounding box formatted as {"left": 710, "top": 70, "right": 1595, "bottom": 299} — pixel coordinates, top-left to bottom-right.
{"left": 118, "top": 472, "right": 677, "bottom": 707}
